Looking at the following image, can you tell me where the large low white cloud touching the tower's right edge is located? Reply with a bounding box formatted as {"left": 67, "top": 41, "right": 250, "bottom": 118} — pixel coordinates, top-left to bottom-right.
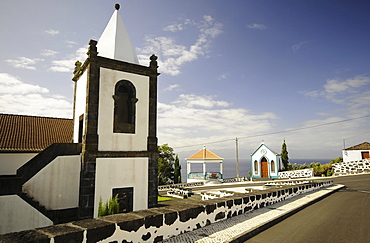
{"left": 158, "top": 94, "right": 277, "bottom": 147}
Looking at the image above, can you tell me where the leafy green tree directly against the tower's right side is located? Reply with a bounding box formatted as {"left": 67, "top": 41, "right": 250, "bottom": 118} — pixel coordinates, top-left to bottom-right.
{"left": 158, "top": 143, "right": 175, "bottom": 185}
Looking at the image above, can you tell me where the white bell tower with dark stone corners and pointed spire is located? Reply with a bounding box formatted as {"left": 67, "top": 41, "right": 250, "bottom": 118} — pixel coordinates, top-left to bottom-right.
{"left": 72, "top": 4, "right": 159, "bottom": 218}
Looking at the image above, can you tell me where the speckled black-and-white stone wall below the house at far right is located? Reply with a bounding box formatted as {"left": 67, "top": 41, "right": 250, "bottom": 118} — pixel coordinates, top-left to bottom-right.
{"left": 332, "top": 159, "right": 370, "bottom": 175}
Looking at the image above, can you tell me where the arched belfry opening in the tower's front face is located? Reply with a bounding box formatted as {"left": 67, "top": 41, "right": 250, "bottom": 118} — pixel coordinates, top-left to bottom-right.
{"left": 113, "top": 80, "right": 138, "bottom": 133}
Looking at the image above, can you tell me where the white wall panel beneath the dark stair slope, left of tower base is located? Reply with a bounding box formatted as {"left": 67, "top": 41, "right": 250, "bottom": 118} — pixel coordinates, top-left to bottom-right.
{"left": 22, "top": 155, "right": 81, "bottom": 209}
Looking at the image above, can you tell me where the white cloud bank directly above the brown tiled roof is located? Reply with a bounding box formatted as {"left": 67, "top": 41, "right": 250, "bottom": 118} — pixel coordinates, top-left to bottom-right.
{"left": 0, "top": 73, "right": 72, "bottom": 118}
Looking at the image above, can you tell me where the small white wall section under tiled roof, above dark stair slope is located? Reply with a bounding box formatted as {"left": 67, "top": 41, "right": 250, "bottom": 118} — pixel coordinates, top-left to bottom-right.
{"left": 0, "top": 153, "right": 37, "bottom": 175}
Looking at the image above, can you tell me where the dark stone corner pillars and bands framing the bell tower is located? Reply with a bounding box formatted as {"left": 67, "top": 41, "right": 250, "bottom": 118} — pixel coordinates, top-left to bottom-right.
{"left": 77, "top": 40, "right": 159, "bottom": 218}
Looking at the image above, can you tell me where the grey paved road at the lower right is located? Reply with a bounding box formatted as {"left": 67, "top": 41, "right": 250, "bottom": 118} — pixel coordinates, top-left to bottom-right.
{"left": 246, "top": 174, "right": 370, "bottom": 243}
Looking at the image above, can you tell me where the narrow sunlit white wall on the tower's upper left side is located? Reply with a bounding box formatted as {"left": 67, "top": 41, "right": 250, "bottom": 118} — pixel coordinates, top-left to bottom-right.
{"left": 73, "top": 71, "right": 87, "bottom": 143}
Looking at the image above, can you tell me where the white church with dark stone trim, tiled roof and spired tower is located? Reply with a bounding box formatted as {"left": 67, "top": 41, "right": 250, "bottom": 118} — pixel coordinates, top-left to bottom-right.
{"left": 0, "top": 4, "right": 159, "bottom": 234}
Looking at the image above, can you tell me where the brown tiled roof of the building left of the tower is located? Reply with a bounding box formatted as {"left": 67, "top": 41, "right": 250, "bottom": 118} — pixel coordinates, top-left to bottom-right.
{"left": 0, "top": 114, "right": 73, "bottom": 153}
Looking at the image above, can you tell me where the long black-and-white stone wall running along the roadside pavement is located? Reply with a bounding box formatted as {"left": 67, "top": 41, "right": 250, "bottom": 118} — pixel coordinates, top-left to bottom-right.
{"left": 0, "top": 181, "right": 333, "bottom": 243}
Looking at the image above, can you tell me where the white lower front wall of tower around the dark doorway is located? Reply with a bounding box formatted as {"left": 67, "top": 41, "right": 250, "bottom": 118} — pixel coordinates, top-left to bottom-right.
{"left": 94, "top": 158, "right": 148, "bottom": 217}
